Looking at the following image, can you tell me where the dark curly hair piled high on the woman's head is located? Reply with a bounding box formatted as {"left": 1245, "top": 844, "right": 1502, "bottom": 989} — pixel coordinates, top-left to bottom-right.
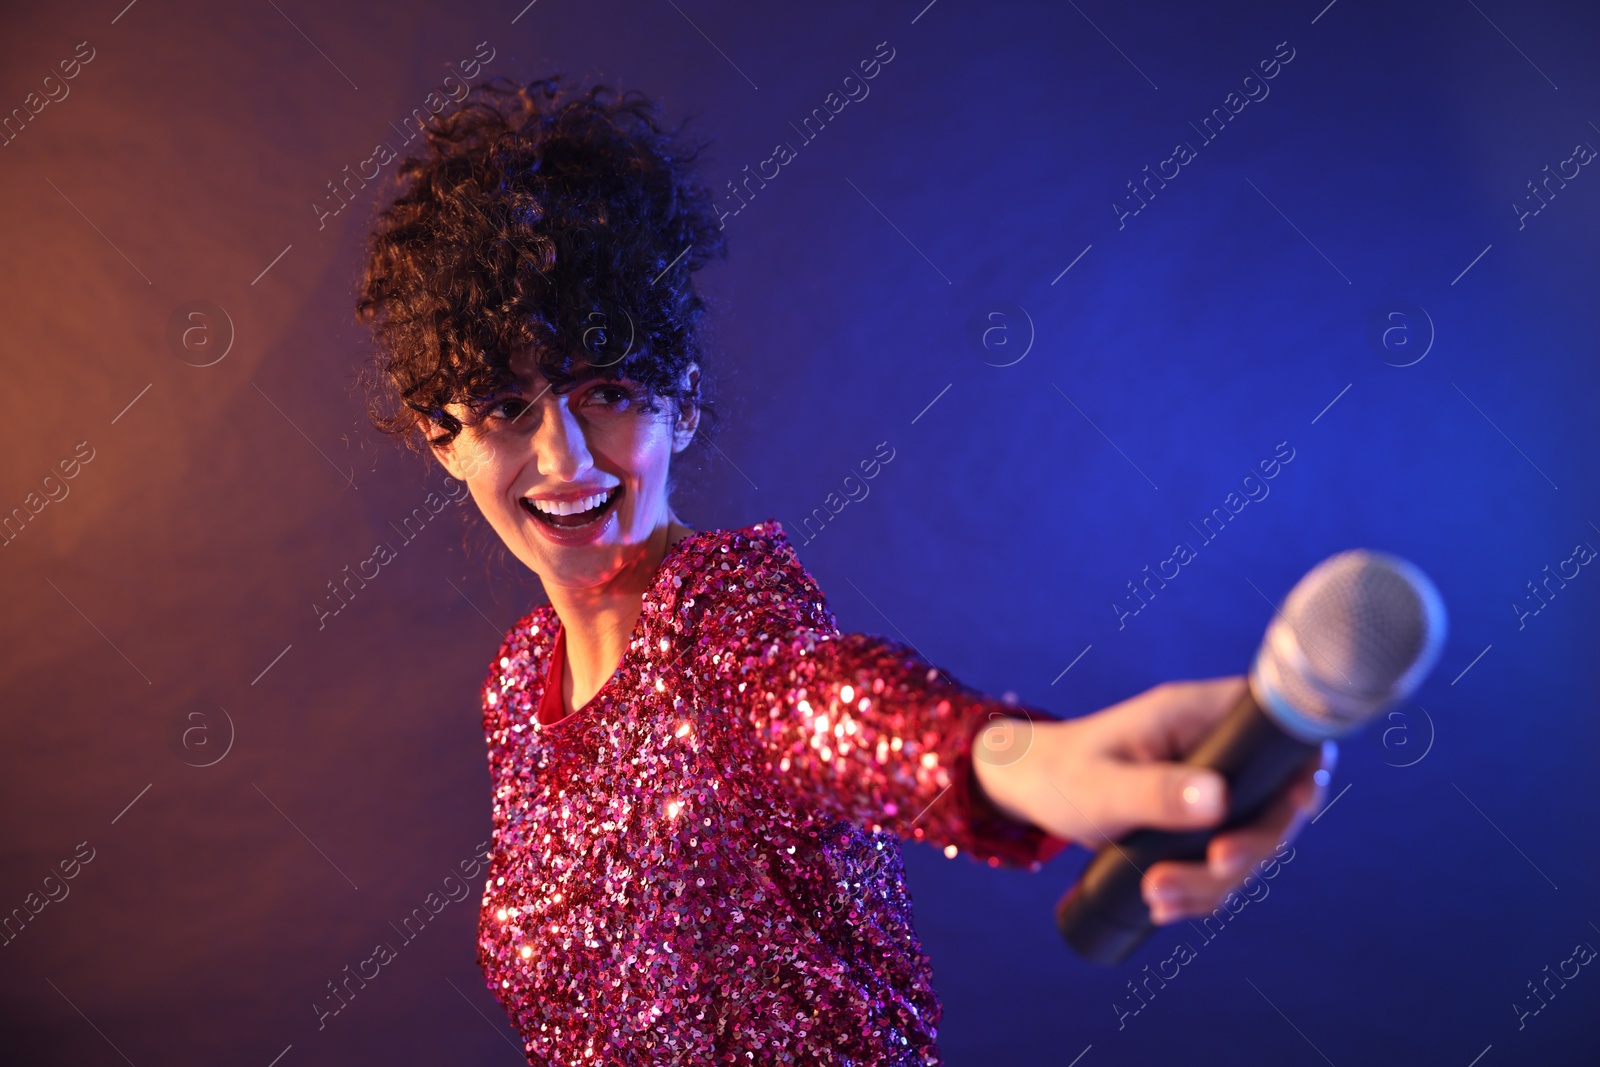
{"left": 355, "top": 74, "right": 725, "bottom": 451}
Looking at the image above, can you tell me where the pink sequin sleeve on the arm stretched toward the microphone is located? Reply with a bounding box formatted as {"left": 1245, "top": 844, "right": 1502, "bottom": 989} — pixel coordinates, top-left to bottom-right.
{"left": 693, "top": 533, "right": 1067, "bottom": 865}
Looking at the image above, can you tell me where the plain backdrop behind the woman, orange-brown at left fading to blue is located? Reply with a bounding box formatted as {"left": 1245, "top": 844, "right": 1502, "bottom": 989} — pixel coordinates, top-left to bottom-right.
{"left": 0, "top": 0, "right": 1600, "bottom": 1067}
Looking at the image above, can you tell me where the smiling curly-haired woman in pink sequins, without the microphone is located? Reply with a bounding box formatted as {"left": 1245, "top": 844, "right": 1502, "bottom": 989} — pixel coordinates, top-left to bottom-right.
{"left": 358, "top": 80, "right": 1325, "bottom": 1064}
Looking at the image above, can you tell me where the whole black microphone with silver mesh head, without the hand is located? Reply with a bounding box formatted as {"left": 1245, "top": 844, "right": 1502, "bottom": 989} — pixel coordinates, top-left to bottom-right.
{"left": 1056, "top": 549, "right": 1445, "bottom": 965}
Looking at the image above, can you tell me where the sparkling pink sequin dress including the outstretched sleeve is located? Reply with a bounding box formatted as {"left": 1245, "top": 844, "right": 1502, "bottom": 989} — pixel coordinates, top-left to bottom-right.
{"left": 478, "top": 520, "right": 1067, "bottom": 1065}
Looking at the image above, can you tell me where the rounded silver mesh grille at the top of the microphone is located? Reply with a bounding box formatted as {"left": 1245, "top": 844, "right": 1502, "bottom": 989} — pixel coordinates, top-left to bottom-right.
{"left": 1250, "top": 549, "right": 1445, "bottom": 741}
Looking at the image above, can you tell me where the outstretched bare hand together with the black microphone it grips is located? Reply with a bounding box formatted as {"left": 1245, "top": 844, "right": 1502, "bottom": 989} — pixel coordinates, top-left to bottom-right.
{"left": 973, "top": 550, "right": 1445, "bottom": 963}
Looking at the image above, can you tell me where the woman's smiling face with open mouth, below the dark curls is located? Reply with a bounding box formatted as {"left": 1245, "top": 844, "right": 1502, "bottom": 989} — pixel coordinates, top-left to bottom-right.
{"left": 424, "top": 357, "right": 699, "bottom": 589}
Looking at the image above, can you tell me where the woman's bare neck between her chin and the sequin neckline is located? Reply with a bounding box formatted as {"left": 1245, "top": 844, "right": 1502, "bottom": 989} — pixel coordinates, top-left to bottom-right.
{"left": 546, "top": 514, "right": 693, "bottom": 712}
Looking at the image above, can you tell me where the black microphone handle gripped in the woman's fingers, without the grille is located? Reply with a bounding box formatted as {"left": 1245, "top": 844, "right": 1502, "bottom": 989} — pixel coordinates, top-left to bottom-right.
{"left": 1056, "top": 688, "right": 1322, "bottom": 965}
